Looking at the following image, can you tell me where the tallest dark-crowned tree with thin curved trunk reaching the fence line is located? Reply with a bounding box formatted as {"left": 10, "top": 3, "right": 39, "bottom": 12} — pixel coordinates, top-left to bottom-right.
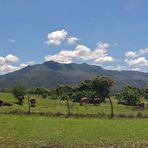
{"left": 92, "top": 76, "right": 114, "bottom": 119}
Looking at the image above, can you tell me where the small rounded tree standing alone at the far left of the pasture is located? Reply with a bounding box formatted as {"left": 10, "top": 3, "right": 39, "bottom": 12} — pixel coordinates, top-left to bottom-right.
{"left": 12, "top": 85, "right": 26, "bottom": 105}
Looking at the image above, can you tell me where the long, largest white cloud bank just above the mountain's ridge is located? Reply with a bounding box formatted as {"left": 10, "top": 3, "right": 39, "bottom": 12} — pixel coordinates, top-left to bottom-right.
{"left": 45, "top": 42, "right": 114, "bottom": 63}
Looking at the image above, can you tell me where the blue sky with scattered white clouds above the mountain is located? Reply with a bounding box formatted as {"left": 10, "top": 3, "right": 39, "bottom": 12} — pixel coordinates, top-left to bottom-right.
{"left": 0, "top": 0, "right": 148, "bottom": 74}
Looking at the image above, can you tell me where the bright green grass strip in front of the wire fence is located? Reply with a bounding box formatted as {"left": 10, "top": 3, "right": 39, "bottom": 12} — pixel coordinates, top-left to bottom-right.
{"left": 0, "top": 114, "right": 148, "bottom": 148}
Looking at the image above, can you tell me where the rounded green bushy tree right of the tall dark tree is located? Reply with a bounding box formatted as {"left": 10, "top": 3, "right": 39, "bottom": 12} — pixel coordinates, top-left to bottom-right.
{"left": 119, "top": 86, "right": 141, "bottom": 106}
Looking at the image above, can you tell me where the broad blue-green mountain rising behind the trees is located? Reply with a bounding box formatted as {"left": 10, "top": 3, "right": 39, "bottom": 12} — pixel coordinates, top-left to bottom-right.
{"left": 0, "top": 61, "right": 148, "bottom": 89}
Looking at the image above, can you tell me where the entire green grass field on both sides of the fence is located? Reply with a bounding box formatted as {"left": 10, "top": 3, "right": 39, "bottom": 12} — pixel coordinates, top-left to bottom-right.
{"left": 0, "top": 93, "right": 148, "bottom": 148}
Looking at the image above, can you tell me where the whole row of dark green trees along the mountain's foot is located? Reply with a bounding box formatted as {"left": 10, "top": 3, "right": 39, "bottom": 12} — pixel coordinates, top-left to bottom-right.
{"left": 0, "top": 76, "right": 148, "bottom": 118}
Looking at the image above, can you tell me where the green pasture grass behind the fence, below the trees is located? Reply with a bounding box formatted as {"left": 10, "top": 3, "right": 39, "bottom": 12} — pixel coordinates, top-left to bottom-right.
{"left": 0, "top": 93, "right": 148, "bottom": 118}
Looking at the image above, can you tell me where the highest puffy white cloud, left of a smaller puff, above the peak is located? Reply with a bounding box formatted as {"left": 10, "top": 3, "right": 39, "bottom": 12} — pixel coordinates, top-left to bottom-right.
{"left": 46, "top": 29, "right": 68, "bottom": 45}
